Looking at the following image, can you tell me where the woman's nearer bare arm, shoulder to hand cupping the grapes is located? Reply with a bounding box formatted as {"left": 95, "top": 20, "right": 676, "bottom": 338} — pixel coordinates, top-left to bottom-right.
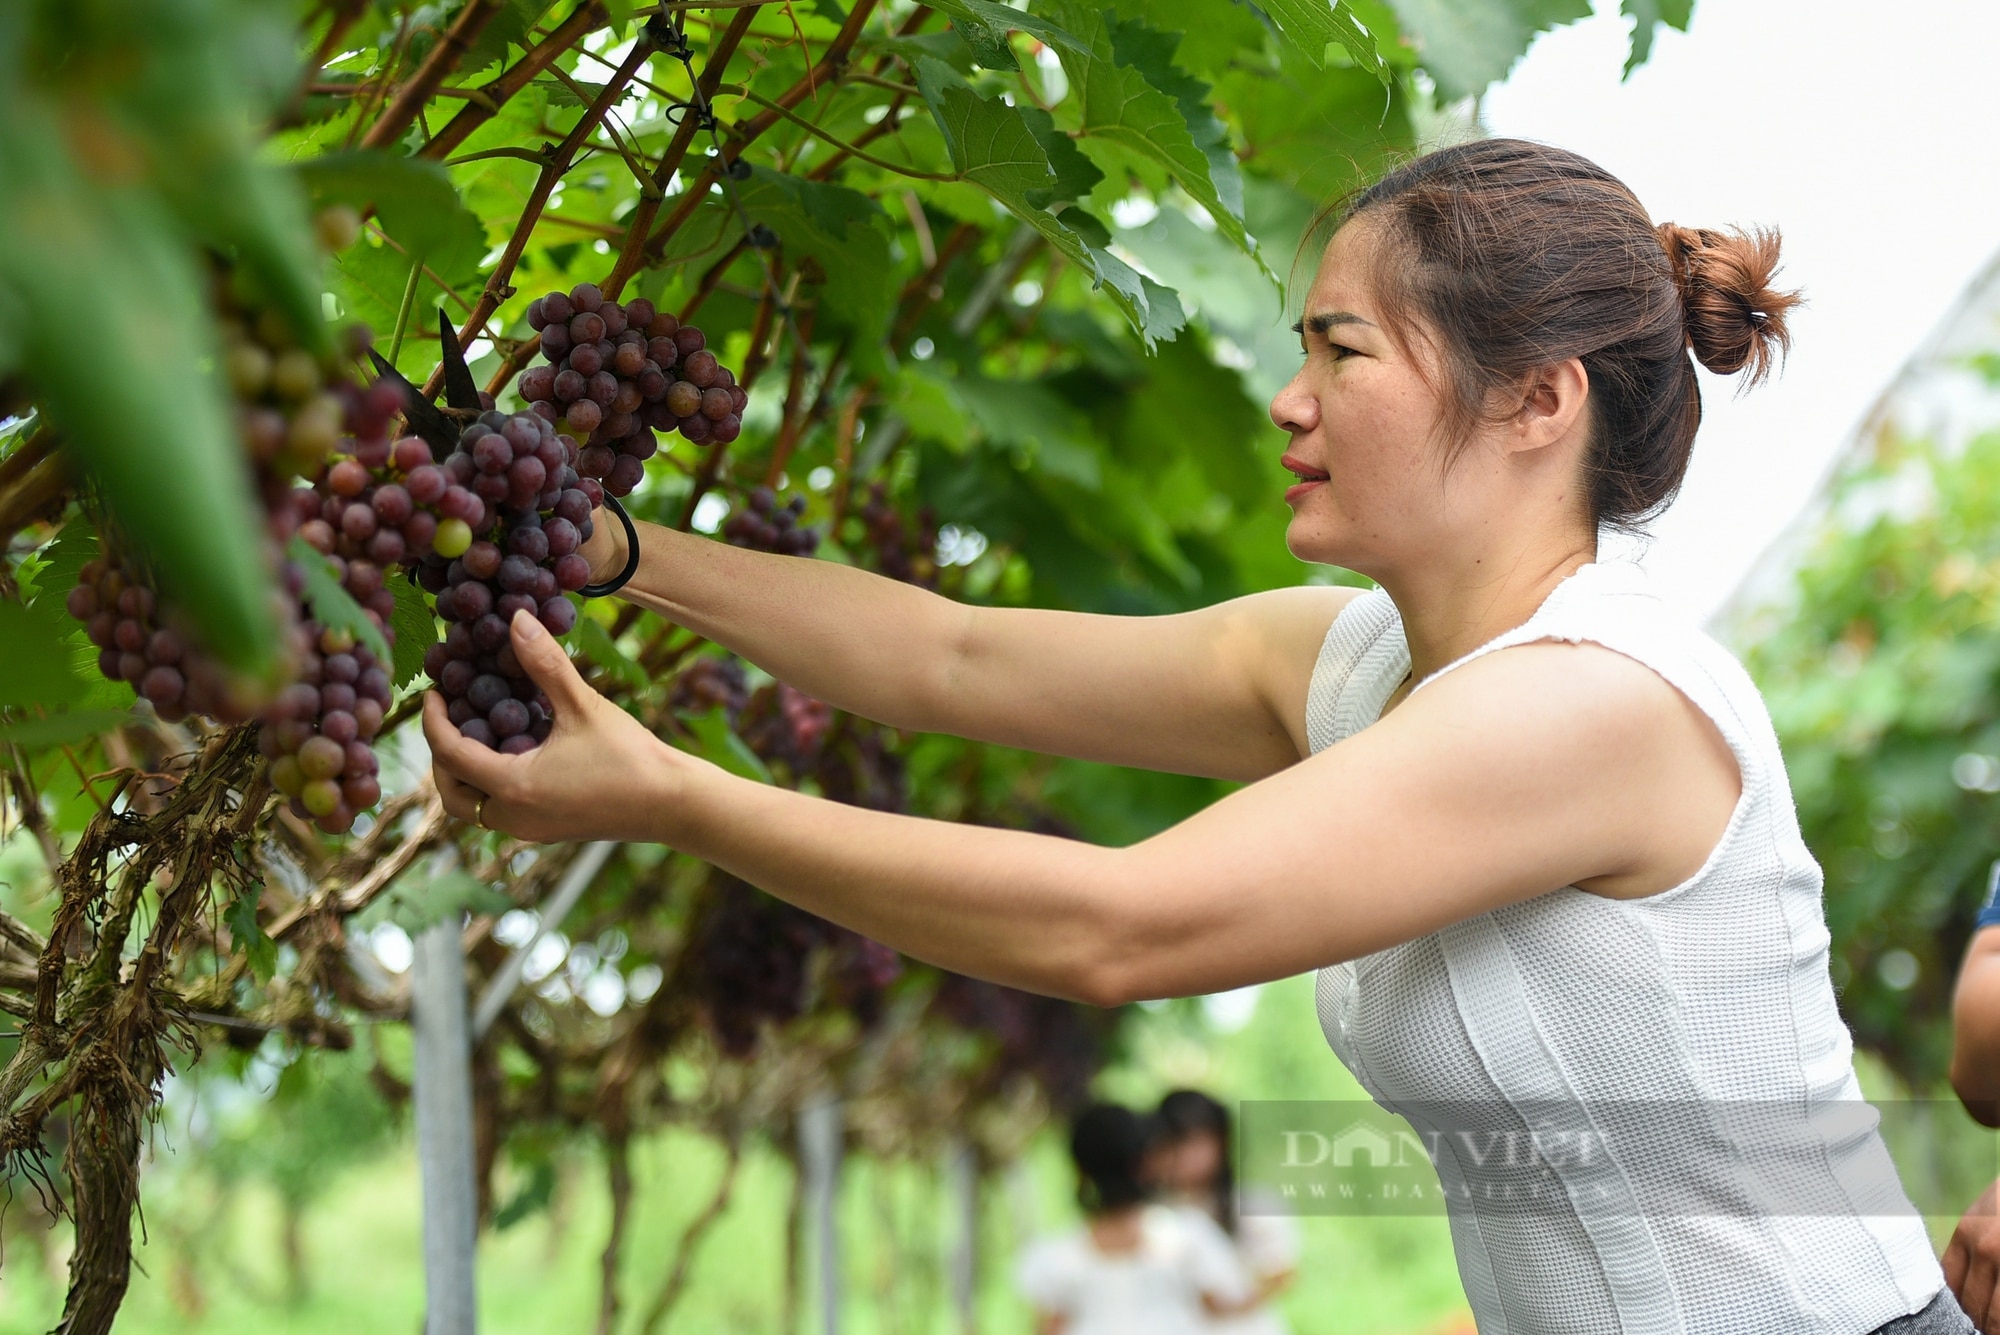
{"left": 426, "top": 631, "right": 1738, "bottom": 1005}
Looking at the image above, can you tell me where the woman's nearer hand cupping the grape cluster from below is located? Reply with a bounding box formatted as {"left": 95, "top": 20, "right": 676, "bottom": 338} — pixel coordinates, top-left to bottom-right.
{"left": 424, "top": 612, "right": 720, "bottom": 843}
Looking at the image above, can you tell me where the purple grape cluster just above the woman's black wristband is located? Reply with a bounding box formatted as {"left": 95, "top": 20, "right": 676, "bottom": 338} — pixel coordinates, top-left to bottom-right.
{"left": 516, "top": 284, "right": 750, "bottom": 496}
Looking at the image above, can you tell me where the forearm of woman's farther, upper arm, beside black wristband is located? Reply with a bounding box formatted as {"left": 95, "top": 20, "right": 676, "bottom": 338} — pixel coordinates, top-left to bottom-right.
{"left": 598, "top": 524, "right": 966, "bottom": 731}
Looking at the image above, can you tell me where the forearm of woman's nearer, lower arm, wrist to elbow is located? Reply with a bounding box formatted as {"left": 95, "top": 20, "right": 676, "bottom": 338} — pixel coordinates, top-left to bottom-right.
{"left": 658, "top": 771, "right": 1134, "bottom": 1005}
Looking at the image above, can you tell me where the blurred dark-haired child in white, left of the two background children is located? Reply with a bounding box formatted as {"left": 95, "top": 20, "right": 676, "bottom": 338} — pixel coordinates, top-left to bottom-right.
{"left": 1016, "top": 1103, "right": 1252, "bottom": 1335}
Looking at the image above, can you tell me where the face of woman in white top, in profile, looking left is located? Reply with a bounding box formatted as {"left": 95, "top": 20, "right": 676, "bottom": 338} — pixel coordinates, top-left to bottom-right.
{"left": 1270, "top": 218, "right": 1450, "bottom": 580}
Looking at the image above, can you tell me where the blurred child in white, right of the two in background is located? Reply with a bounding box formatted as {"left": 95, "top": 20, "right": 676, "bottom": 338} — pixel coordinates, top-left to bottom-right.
{"left": 1148, "top": 1089, "right": 1298, "bottom": 1335}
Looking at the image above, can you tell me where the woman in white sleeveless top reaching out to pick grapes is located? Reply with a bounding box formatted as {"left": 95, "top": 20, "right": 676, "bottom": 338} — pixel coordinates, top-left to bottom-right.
{"left": 426, "top": 140, "right": 1972, "bottom": 1335}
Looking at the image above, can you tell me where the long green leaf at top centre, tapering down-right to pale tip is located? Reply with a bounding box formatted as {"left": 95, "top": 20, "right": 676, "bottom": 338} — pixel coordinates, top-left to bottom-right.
{"left": 916, "top": 60, "right": 1186, "bottom": 348}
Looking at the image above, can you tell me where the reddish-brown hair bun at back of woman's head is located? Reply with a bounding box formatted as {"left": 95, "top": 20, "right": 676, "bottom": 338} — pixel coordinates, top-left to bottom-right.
{"left": 1656, "top": 222, "right": 1802, "bottom": 384}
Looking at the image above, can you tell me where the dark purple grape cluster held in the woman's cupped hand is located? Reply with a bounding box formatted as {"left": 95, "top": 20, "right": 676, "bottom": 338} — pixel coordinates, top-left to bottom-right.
{"left": 410, "top": 412, "right": 604, "bottom": 755}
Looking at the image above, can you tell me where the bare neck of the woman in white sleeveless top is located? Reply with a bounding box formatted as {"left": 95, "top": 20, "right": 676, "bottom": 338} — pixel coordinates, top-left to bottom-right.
{"left": 1382, "top": 532, "right": 1598, "bottom": 699}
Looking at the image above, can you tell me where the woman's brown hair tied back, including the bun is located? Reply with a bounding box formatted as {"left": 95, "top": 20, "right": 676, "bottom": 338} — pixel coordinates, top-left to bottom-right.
{"left": 1336, "top": 140, "right": 1800, "bottom": 528}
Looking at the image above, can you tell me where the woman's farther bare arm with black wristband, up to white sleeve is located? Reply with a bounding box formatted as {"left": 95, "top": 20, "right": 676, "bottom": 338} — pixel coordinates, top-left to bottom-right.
{"left": 590, "top": 522, "right": 1354, "bottom": 779}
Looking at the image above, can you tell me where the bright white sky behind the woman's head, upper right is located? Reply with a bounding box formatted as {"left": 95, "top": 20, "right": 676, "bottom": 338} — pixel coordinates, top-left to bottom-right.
{"left": 1484, "top": 0, "right": 2000, "bottom": 614}
